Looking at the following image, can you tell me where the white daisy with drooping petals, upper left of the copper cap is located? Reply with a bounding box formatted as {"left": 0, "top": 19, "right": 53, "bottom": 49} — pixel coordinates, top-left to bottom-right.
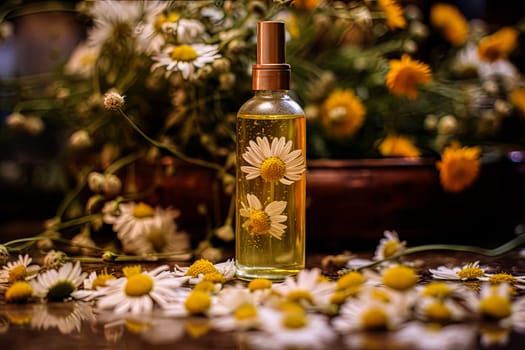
{"left": 151, "top": 44, "right": 221, "bottom": 79}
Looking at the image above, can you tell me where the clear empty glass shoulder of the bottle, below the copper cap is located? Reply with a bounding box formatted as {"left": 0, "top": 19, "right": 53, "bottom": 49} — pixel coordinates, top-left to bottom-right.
{"left": 239, "top": 94, "right": 304, "bottom": 115}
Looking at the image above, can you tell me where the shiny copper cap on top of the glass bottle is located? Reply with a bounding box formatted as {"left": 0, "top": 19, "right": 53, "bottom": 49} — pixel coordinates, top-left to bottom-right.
{"left": 252, "top": 21, "right": 290, "bottom": 90}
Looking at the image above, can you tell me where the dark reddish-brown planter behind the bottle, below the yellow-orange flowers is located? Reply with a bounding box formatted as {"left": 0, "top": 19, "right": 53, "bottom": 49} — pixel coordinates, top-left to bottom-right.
{"left": 137, "top": 154, "right": 525, "bottom": 252}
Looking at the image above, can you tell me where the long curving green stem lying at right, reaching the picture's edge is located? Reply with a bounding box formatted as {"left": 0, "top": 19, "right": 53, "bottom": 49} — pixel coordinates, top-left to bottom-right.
{"left": 350, "top": 234, "right": 525, "bottom": 271}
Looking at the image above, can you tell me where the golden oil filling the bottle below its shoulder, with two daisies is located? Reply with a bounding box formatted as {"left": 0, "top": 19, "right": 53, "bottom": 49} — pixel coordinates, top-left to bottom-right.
{"left": 236, "top": 113, "right": 306, "bottom": 280}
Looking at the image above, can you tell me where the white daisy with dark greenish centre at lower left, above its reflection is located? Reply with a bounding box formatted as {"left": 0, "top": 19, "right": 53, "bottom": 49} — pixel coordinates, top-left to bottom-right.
{"left": 31, "top": 261, "right": 86, "bottom": 301}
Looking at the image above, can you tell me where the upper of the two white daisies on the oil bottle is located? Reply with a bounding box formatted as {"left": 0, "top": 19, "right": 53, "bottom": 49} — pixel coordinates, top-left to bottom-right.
{"left": 241, "top": 136, "right": 306, "bottom": 185}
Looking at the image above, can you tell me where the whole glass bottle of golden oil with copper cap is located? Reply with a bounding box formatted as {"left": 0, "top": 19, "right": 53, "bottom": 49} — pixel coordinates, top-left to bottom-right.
{"left": 235, "top": 21, "right": 306, "bottom": 280}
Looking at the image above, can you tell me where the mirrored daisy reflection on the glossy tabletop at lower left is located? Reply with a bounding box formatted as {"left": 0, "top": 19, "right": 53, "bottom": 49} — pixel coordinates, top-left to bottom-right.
{"left": 31, "top": 302, "right": 95, "bottom": 334}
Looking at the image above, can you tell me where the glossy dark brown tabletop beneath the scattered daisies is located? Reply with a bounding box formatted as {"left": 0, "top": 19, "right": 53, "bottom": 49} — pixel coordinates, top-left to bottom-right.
{"left": 0, "top": 251, "right": 525, "bottom": 350}
